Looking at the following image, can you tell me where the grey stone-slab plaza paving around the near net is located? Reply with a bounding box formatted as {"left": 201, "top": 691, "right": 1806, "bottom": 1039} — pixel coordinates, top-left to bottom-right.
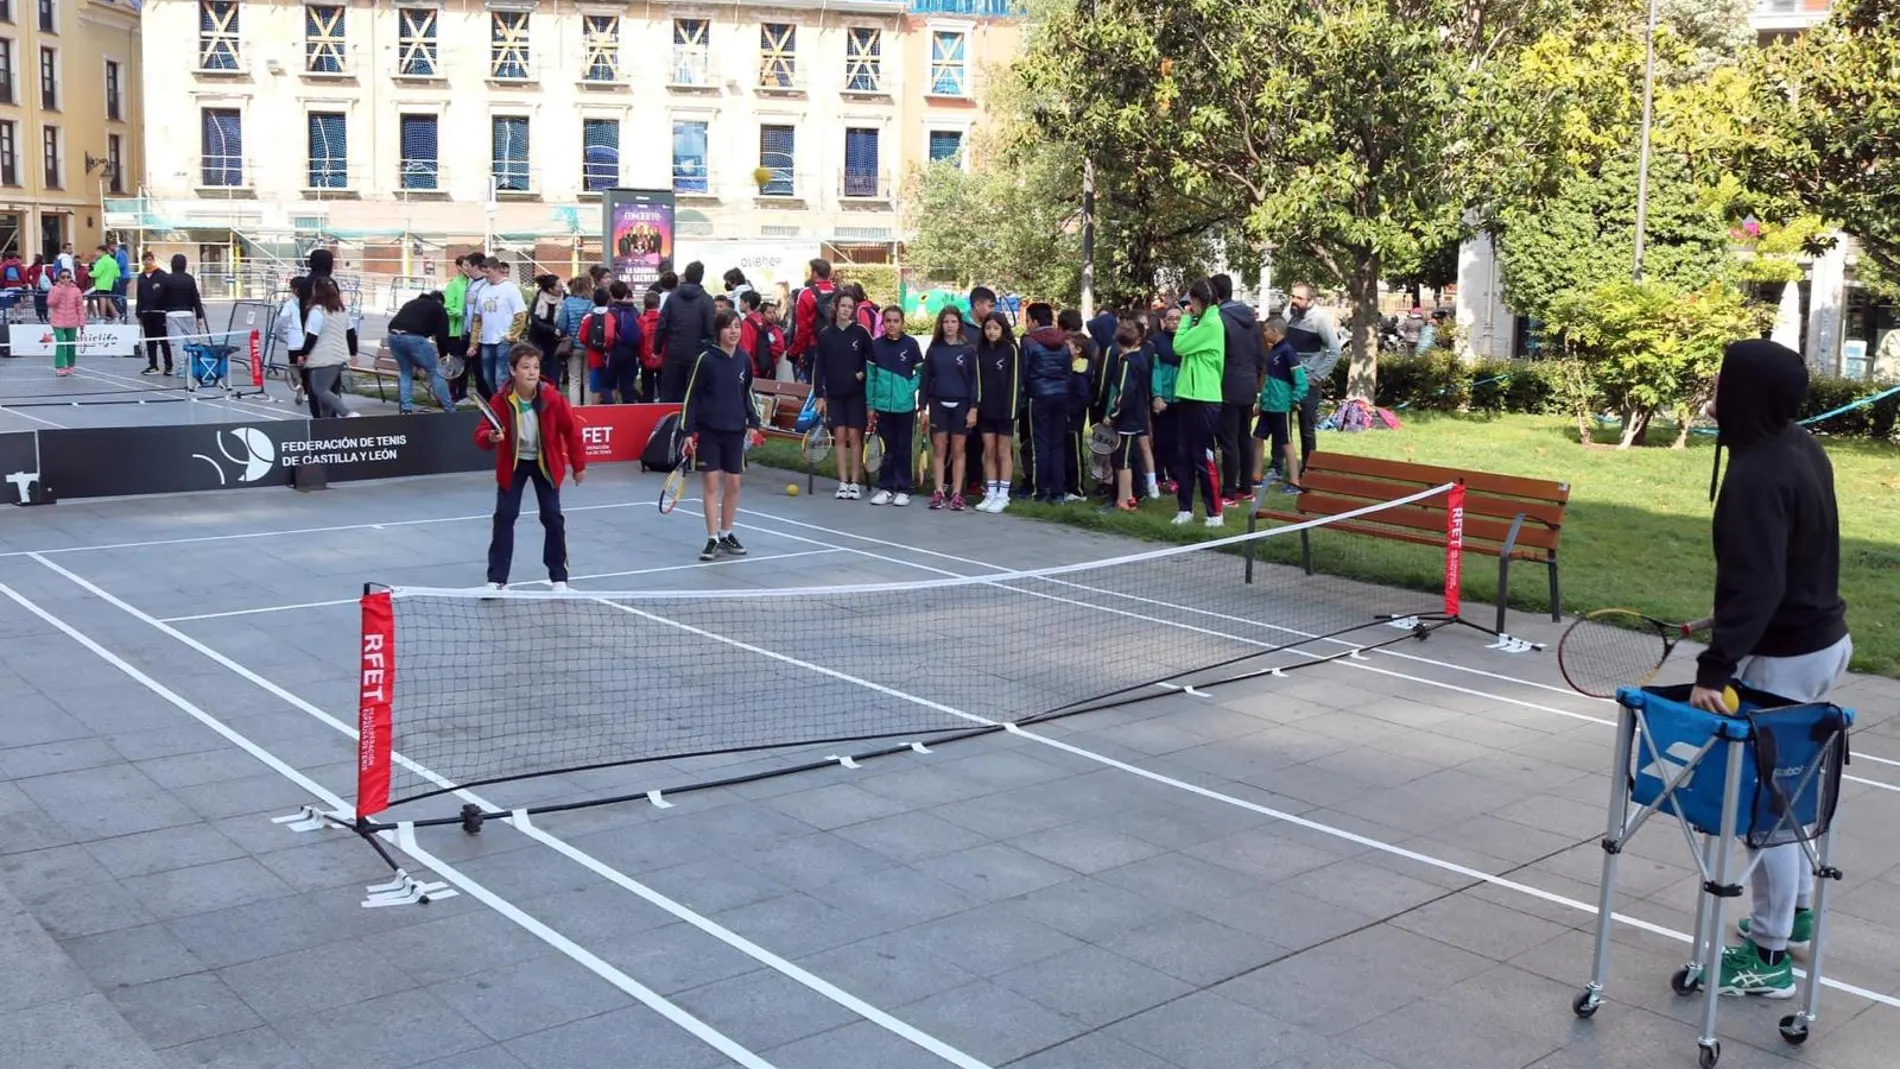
{"left": 0, "top": 467, "right": 1900, "bottom": 1069}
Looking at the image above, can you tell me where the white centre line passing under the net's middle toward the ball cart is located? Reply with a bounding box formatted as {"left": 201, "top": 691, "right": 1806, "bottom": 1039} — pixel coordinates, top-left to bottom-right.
{"left": 585, "top": 587, "right": 1900, "bottom": 1008}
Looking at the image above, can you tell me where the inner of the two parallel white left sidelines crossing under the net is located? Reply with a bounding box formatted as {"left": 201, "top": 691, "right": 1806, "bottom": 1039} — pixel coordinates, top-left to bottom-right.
{"left": 29, "top": 553, "right": 992, "bottom": 1069}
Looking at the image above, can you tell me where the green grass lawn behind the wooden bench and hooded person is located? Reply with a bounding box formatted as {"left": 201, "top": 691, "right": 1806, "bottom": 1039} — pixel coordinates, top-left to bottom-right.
{"left": 754, "top": 412, "right": 1900, "bottom": 676}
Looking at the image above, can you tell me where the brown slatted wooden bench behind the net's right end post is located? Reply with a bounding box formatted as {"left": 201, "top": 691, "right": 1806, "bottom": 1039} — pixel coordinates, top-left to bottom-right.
{"left": 1246, "top": 454, "right": 1569, "bottom": 632}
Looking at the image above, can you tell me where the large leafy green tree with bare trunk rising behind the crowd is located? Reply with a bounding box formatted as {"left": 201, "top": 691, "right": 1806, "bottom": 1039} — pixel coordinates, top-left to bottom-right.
{"left": 1017, "top": 0, "right": 1577, "bottom": 397}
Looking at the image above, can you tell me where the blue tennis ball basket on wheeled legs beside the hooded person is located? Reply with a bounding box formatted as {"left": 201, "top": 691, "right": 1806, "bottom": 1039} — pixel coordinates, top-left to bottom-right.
{"left": 1571, "top": 685, "right": 1854, "bottom": 1069}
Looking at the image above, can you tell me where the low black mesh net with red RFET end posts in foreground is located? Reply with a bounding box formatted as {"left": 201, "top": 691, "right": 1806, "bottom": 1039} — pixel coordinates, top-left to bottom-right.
{"left": 357, "top": 486, "right": 1459, "bottom": 818}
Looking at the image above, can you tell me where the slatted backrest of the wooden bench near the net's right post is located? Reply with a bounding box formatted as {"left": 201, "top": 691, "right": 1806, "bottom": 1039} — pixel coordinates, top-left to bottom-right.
{"left": 1300, "top": 454, "right": 1569, "bottom": 551}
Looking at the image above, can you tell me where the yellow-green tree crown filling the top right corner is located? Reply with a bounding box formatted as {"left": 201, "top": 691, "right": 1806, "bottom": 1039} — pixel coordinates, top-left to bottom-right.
{"left": 1742, "top": 0, "right": 1900, "bottom": 277}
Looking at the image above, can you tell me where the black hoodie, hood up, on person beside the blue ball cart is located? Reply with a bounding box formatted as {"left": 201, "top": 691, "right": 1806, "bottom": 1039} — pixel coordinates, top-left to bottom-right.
{"left": 1695, "top": 342, "right": 1847, "bottom": 687}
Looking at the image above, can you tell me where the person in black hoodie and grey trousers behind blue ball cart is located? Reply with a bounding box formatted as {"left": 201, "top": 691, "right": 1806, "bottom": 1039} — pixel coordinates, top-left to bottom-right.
{"left": 1689, "top": 340, "right": 1854, "bottom": 999}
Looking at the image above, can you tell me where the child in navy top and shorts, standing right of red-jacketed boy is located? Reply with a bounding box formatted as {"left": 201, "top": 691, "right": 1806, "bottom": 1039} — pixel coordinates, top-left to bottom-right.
{"left": 680, "top": 308, "right": 762, "bottom": 560}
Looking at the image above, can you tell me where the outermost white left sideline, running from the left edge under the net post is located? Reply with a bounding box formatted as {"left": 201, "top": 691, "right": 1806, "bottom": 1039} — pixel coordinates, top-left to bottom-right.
{"left": 0, "top": 583, "right": 775, "bottom": 1069}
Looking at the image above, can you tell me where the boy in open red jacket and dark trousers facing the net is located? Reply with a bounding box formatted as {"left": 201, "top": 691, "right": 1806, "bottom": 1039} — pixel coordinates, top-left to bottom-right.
{"left": 475, "top": 344, "right": 587, "bottom": 591}
